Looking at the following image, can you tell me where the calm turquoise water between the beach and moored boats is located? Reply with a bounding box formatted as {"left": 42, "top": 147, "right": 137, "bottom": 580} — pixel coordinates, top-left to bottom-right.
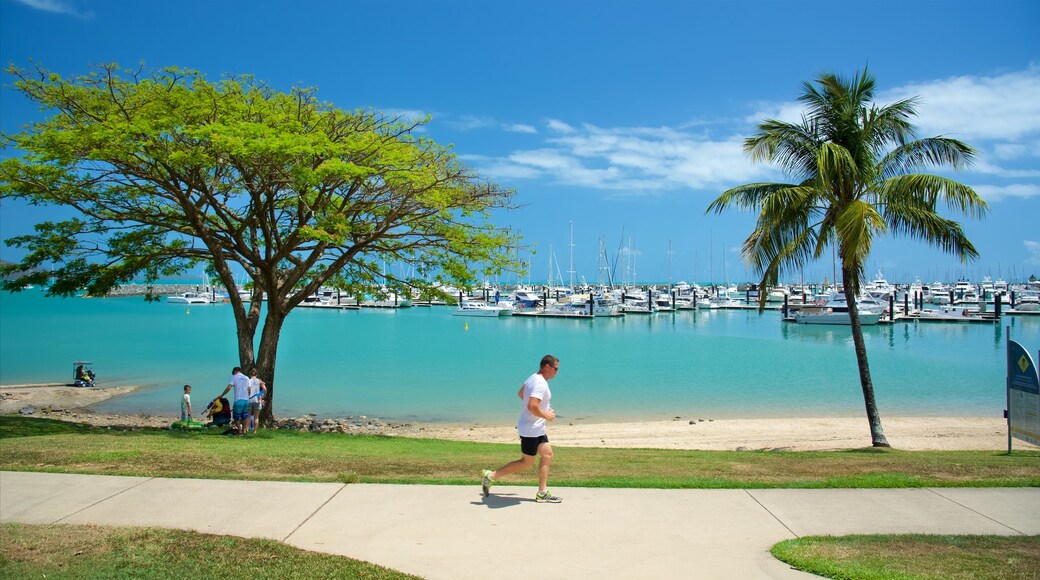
{"left": 0, "top": 291, "right": 1040, "bottom": 422}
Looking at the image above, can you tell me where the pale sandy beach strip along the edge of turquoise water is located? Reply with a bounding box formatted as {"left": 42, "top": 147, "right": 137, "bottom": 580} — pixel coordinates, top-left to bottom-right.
{"left": 0, "top": 385, "right": 1038, "bottom": 451}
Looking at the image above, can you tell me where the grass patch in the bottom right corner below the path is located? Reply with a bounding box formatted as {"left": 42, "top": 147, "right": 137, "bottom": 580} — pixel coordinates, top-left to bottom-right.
{"left": 772, "top": 534, "right": 1040, "bottom": 580}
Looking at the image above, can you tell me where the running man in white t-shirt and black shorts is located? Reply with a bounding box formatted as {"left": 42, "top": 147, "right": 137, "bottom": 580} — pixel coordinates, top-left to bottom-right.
{"left": 482, "top": 354, "right": 563, "bottom": 503}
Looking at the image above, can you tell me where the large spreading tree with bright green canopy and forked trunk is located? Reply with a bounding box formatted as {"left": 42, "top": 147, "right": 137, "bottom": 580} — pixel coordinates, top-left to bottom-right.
{"left": 0, "top": 64, "right": 513, "bottom": 423}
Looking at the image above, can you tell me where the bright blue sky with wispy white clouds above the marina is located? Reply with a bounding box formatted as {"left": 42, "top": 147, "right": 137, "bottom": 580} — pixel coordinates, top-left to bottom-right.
{"left": 0, "top": 0, "right": 1040, "bottom": 283}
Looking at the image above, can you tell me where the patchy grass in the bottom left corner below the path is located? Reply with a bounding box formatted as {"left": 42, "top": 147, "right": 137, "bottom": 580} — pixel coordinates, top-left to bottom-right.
{"left": 0, "top": 524, "right": 416, "bottom": 580}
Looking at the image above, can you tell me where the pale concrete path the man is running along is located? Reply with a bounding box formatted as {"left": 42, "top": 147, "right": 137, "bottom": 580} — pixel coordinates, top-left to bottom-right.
{"left": 0, "top": 472, "right": 1040, "bottom": 580}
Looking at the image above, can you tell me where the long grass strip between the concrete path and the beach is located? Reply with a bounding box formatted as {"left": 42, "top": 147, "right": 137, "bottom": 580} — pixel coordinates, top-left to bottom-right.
{"left": 0, "top": 416, "right": 1040, "bottom": 489}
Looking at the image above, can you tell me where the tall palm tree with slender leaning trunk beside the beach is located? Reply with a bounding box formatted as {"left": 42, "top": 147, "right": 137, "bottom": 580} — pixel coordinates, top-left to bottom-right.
{"left": 707, "top": 69, "right": 988, "bottom": 447}
